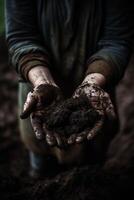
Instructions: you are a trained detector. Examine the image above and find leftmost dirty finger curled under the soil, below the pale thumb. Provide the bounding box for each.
[30,114,45,140]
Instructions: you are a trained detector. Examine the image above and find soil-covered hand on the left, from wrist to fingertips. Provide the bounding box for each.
[20,84,64,147]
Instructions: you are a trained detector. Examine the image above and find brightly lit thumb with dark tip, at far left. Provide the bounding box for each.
[20,92,37,119]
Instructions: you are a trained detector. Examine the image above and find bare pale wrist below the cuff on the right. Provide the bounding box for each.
[83,73,106,87]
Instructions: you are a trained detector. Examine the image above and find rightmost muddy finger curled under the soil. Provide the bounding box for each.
[87,118,104,140]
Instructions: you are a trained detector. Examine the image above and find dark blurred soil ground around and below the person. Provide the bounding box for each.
[0,38,134,200]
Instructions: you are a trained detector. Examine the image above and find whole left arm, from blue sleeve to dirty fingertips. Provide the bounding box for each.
[6,0,65,146]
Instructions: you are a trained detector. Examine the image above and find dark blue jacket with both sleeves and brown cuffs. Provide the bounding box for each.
[6,0,131,87]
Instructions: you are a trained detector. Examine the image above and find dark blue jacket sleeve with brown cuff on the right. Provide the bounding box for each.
[87,0,133,83]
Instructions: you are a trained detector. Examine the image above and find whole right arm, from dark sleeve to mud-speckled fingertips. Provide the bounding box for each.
[68,0,133,144]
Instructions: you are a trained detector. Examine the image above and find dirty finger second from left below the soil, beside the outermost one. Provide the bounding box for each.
[43,124,57,147]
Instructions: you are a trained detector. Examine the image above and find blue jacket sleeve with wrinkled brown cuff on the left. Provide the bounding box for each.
[5,0,49,79]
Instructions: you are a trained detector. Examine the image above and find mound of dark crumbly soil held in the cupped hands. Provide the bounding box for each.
[44,96,100,138]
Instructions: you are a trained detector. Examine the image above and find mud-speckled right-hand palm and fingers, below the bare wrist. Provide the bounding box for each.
[68,73,116,144]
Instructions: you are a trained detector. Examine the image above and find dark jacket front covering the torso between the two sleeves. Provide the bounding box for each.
[35,0,102,94]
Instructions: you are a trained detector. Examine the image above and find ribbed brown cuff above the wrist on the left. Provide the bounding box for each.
[18,53,50,81]
